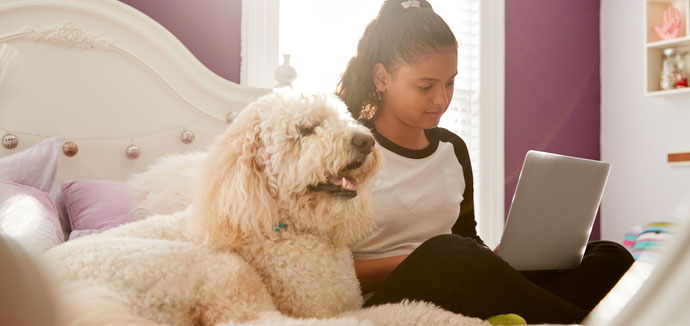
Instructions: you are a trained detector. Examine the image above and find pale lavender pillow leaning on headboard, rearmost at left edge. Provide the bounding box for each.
[0,137,62,196]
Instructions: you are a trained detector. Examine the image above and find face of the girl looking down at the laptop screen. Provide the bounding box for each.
[374,46,458,129]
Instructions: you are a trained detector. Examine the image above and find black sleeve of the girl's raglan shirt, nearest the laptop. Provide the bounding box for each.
[438,128,484,245]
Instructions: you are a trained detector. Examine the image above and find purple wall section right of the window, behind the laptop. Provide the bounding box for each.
[505,0,600,239]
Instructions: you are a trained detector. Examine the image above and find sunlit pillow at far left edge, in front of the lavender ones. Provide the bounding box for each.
[0,181,64,255]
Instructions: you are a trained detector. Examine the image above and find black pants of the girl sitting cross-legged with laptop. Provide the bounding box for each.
[364,234,633,324]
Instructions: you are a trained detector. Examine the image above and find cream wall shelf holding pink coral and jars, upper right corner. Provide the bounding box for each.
[644,0,690,96]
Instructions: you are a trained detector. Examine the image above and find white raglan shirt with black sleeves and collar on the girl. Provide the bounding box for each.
[350,124,483,260]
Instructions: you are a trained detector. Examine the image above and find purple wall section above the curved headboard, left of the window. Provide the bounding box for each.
[120,0,242,83]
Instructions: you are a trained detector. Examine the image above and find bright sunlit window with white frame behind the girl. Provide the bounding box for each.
[242,0,504,246]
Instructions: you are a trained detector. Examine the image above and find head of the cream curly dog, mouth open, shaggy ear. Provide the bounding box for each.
[194,93,379,246]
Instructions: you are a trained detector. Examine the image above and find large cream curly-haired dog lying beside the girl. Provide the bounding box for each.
[43,93,484,325]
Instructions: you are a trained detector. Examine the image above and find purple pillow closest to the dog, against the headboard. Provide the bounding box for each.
[62,180,134,240]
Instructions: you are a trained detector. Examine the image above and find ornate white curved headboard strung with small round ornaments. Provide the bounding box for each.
[0,0,269,180]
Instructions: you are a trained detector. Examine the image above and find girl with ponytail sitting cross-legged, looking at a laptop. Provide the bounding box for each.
[336,0,633,323]
